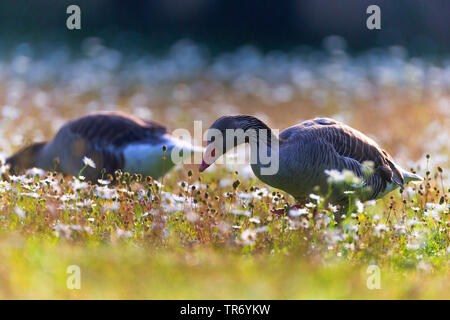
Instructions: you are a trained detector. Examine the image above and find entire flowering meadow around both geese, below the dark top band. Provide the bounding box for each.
[0,41,450,299]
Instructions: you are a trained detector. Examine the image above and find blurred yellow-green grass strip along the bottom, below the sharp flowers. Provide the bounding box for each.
[0,239,449,299]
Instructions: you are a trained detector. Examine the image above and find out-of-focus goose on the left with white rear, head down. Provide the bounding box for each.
[6,112,202,180]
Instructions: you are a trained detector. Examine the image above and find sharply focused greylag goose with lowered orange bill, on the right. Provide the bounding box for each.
[199,115,422,205]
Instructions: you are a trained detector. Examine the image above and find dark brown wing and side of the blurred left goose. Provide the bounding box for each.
[47,112,167,178]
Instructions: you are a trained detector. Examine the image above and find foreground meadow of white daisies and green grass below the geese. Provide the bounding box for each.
[0,164,450,299]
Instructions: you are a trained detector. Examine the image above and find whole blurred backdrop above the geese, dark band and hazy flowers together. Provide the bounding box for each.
[0,0,450,174]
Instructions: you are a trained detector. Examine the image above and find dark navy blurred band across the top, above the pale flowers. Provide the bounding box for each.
[0,0,450,54]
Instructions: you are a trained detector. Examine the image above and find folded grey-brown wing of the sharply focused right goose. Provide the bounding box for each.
[280,118,404,198]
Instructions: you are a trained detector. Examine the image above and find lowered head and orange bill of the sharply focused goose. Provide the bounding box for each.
[199,115,270,172]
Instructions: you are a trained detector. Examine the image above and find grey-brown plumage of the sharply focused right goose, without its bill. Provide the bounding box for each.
[202,116,421,203]
